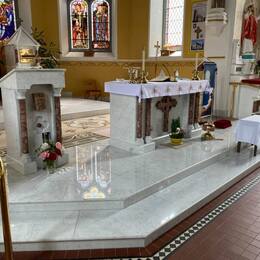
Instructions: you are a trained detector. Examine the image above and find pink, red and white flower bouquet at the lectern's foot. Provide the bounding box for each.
[36,142,63,174]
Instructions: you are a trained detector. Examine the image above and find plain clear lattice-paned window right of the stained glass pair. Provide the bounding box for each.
[163,0,184,46]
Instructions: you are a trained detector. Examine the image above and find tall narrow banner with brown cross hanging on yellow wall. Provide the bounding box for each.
[190,1,207,51]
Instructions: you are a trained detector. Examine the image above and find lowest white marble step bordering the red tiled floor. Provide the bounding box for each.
[1,145,260,250]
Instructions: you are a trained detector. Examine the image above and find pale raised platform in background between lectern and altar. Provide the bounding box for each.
[0,97,110,130]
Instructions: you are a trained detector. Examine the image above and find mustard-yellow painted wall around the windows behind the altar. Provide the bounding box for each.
[31,0,203,96]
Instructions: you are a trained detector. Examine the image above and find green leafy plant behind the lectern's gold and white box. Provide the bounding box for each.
[32,28,60,69]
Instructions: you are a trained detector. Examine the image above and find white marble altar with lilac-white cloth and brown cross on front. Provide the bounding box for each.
[105,80,209,152]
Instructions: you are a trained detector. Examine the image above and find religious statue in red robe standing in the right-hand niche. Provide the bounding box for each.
[242,4,257,53]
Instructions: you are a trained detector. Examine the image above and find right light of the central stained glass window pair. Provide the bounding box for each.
[91,0,110,49]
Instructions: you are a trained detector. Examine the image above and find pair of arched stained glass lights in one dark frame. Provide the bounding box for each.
[68,0,112,52]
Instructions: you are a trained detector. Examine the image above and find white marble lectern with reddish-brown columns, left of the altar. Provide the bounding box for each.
[0,68,68,174]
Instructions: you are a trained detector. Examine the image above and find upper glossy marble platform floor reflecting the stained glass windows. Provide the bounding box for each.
[8,125,234,210]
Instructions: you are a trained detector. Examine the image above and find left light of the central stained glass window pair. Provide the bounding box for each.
[70,0,89,49]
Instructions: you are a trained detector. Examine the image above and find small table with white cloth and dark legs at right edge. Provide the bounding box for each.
[236,115,260,156]
